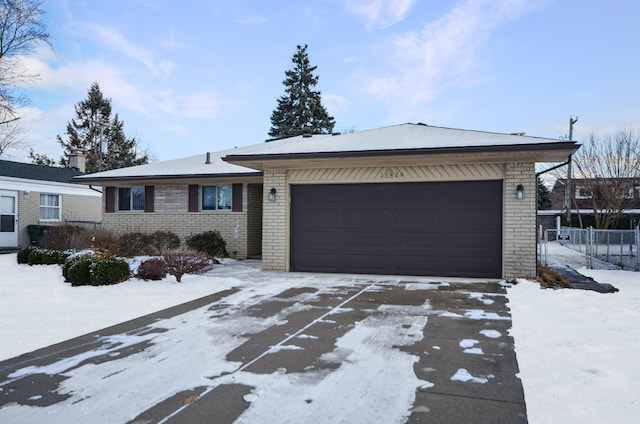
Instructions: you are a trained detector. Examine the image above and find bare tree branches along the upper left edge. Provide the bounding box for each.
[0,0,50,155]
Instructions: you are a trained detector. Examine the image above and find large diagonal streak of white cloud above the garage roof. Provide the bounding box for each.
[367,0,545,120]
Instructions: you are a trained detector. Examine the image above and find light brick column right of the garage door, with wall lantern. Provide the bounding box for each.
[503,162,537,278]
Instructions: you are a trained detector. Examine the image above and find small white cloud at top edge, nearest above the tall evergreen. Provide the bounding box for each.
[346,0,416,29]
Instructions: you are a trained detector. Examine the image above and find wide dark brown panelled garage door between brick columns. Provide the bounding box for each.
[291,181,502,278]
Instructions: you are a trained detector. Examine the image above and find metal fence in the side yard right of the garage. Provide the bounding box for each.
[538,227,640,271]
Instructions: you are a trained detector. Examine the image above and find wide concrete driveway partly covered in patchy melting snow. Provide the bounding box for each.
[0,261,527,424]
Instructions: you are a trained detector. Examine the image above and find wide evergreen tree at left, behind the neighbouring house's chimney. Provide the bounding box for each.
[57,82,149,173]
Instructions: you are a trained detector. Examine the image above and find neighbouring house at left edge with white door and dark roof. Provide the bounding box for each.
[0,160,102,249]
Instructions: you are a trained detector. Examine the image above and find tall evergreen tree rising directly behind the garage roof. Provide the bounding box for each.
[269,44,335,140]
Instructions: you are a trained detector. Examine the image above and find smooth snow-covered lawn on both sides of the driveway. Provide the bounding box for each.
[0,248,640,424]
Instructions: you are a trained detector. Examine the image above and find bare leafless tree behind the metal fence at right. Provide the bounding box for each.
[572,128,640,228]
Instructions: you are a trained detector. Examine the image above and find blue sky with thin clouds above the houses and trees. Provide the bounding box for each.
[10,0,640,161]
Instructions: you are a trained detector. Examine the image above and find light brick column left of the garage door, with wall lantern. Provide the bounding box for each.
[262,169,289,271]
